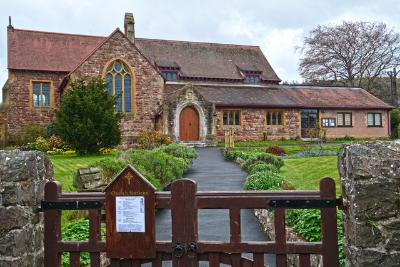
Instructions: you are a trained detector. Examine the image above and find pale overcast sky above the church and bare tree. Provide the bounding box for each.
[0,0,400,102]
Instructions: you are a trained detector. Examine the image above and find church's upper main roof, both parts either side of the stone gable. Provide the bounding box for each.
[8,29,280,83]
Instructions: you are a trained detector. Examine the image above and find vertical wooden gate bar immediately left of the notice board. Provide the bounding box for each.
[89,209,101,267]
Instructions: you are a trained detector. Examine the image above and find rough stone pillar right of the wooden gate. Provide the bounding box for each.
[339,141,400,267]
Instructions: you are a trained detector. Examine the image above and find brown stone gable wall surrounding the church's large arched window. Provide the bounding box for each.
[71,31,164,150]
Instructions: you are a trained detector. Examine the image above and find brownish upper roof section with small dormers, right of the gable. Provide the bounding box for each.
[135,38,280,82]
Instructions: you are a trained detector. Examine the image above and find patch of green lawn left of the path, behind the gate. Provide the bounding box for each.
[48,153,115,192]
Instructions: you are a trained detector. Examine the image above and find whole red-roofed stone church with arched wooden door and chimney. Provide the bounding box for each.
[0,13,392,146]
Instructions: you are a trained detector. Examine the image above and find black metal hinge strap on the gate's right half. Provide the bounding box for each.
[268,199,342,209]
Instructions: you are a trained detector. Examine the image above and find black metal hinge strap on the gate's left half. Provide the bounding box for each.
[39,200,103,211]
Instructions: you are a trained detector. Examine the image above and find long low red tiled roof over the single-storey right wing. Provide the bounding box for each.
[166,83,393,109]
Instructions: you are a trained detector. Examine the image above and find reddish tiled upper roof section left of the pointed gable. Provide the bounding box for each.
[8,29,105,72]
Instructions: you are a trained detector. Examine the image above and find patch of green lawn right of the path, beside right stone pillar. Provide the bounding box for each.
[280,156,340,195]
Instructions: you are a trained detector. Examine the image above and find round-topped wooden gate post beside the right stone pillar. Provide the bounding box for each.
[319,177,339,267]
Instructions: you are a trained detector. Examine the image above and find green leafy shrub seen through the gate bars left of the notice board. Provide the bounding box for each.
[62,219,106,267]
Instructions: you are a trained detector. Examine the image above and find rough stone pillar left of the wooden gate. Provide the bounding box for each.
[0,150,53,267]
